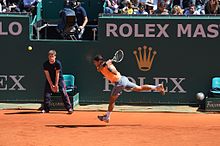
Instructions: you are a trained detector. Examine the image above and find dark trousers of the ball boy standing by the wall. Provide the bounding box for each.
[44,81,72,112]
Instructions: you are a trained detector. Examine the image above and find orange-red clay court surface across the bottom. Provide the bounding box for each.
[0,110,220,146]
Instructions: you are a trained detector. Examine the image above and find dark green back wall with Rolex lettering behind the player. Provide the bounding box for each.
[0,16,220,104]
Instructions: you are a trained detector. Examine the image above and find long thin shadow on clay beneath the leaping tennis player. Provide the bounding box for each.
[46,124,141,128]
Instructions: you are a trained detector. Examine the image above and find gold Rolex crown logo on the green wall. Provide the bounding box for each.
[133,46,157,71]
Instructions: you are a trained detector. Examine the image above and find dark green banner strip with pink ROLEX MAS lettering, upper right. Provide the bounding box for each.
[99,15,220,40]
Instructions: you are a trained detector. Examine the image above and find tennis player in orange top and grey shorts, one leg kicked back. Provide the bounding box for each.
[93,55,165,123]
